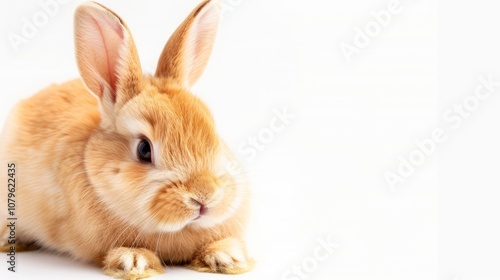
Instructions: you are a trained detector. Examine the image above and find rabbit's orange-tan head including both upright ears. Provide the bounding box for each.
[75,0,245,232]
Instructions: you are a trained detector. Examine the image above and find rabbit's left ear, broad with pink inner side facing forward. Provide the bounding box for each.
[75,2,143,109]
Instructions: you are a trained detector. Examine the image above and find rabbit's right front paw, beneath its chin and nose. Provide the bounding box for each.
[189,238,254,274]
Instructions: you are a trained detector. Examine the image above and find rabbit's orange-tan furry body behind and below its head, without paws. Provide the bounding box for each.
[0,80,250,264]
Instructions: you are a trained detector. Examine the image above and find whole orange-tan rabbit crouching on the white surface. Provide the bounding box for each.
[0,0,255,279]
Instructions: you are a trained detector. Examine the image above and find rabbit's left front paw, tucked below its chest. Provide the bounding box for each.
[104,247,164,280]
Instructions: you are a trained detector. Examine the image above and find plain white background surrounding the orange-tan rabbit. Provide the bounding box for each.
[0,0,500,280]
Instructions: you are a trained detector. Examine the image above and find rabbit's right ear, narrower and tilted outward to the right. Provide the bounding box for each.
[155,0,220,87]
